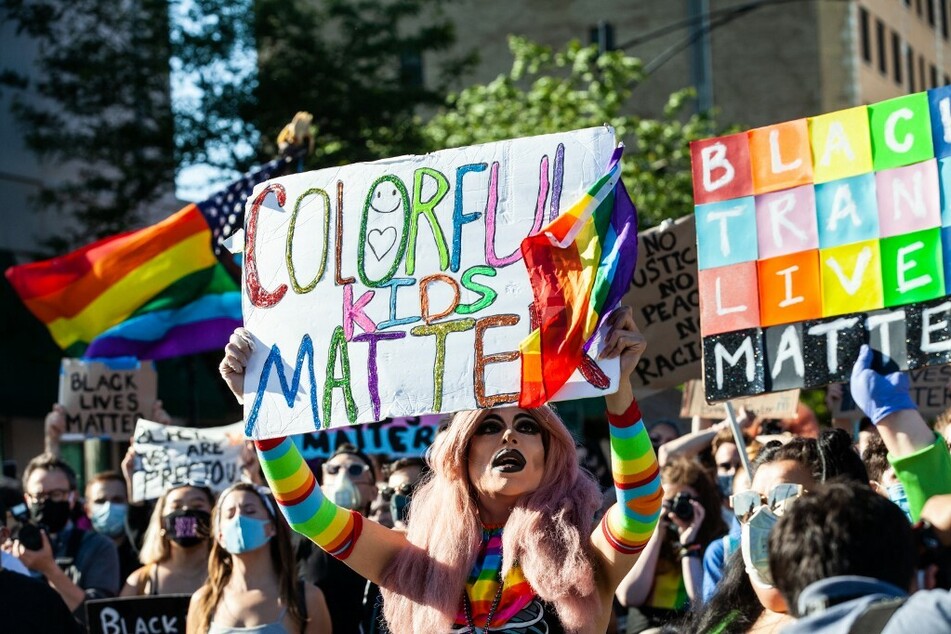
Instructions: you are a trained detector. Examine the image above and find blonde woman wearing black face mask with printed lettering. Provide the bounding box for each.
[121,483,215,597]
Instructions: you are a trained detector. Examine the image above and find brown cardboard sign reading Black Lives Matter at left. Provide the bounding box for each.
[59,357,158,440]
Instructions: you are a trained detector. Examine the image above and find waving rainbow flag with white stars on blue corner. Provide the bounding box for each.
[6,156,295,359]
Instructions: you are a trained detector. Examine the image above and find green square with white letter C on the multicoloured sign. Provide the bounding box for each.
[868,92,934,171]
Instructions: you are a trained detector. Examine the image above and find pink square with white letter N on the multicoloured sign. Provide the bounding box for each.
[875,159,941,238]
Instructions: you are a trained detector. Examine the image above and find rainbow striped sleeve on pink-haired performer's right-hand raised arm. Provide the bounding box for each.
[601,400,664,555]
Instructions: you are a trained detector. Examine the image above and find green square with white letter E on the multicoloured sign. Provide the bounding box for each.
[881,227,944,307]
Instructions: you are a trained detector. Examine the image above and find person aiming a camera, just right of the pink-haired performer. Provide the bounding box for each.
[616,458,727,631]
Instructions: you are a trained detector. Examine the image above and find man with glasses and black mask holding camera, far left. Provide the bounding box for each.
[13,454,120,622]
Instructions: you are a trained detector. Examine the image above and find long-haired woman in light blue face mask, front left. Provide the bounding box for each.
[186,482,331,634]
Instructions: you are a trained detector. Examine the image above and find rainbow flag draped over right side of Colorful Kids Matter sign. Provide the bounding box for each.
[518,146,637,408]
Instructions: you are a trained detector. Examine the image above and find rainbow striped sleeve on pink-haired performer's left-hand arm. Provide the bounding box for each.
[254,437,363,560]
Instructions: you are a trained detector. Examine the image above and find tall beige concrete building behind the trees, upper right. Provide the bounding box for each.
[442,0,951,127]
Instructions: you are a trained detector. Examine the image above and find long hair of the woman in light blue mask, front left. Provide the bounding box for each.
[188,482,307,632]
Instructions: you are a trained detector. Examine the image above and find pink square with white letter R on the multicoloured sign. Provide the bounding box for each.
[756,185,819,260]
